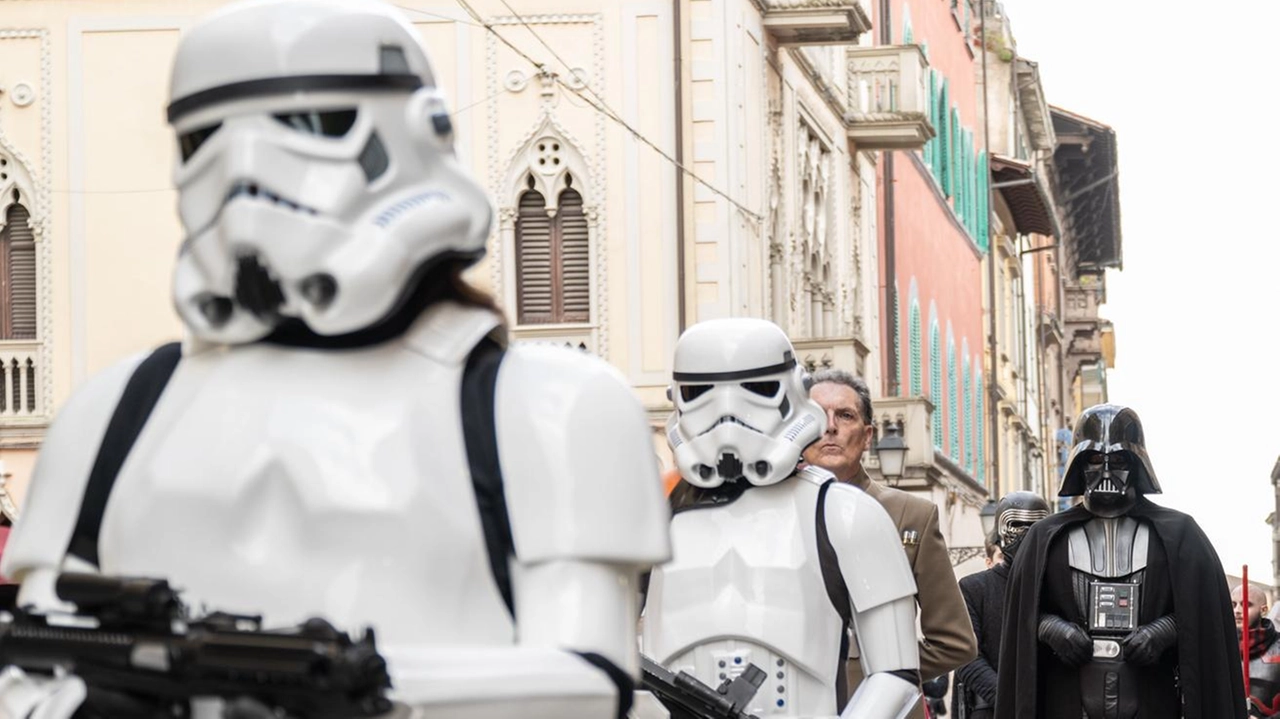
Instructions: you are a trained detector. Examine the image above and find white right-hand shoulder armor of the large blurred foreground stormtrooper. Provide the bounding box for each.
[495,344,671,564]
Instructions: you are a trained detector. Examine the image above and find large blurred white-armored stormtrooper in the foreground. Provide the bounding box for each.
[0,0,669,719]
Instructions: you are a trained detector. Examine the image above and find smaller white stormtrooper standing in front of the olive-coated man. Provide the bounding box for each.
[643,319,920,719]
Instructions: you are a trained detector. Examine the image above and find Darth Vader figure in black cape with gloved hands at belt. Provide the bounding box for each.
[996,404,1245,719]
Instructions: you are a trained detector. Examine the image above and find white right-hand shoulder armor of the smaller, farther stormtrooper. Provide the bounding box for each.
[824,482,915,612]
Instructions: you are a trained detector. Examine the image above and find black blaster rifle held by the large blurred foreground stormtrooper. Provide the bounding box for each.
[0,573,392,719]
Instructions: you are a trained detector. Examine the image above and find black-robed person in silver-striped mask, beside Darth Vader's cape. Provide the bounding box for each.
[951,491,1050,719]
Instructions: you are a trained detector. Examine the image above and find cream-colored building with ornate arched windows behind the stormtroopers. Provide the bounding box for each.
[0,0,928,498]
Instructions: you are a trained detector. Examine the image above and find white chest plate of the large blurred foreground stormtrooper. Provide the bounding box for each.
[100,342,513,646]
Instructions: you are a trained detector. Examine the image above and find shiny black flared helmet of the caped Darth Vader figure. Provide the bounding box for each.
[1057,404,1161,517]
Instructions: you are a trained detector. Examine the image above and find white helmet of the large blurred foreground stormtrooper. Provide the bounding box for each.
[168,0,492,344]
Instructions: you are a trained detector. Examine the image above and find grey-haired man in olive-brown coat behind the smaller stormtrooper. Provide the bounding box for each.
[804,370,978,719]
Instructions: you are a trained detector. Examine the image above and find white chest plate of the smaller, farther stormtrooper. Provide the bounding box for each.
[644,478,844,715]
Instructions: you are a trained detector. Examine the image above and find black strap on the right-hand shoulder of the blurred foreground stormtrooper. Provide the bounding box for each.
[462,338,516,615]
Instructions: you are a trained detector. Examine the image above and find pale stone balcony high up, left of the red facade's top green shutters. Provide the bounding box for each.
[845,45,936,150]
